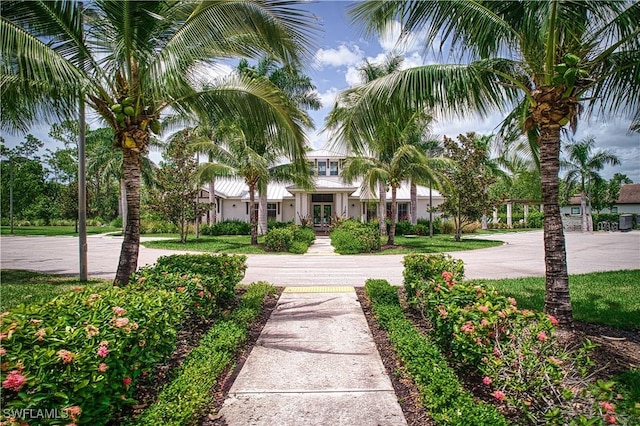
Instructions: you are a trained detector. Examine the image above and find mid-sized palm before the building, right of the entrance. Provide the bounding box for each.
[342,144,440,245]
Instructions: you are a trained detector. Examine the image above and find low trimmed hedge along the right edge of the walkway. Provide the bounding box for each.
[365,279,508,426]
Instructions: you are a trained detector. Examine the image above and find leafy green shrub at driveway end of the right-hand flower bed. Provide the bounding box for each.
[402,254,464,299]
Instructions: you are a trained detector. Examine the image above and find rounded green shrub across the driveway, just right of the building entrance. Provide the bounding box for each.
[330,220,380,254]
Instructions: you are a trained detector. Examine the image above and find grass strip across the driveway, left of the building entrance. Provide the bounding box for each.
[140,235,266,254]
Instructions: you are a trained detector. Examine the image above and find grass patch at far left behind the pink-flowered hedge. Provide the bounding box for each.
[0,269,111,312]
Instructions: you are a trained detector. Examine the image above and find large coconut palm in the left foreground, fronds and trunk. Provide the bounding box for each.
[0,0,315,284]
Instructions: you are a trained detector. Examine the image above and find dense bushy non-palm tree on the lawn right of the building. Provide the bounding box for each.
[440,133,501,241]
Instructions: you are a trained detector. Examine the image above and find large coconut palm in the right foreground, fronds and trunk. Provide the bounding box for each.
[350,0,640,325]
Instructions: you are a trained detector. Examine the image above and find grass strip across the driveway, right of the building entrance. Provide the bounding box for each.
[377,234,502,254]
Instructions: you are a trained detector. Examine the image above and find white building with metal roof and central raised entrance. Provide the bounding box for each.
[200,150,443,230]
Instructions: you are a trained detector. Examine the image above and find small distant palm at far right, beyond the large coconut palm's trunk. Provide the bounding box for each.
[560,137,620,232]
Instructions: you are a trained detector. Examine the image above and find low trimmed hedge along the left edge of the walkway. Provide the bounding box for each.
[135,283,276,426]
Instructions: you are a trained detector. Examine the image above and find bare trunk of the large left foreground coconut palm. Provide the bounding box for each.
[114,149,140,285]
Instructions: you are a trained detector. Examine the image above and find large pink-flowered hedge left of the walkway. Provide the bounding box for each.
[0,255,246,425]
